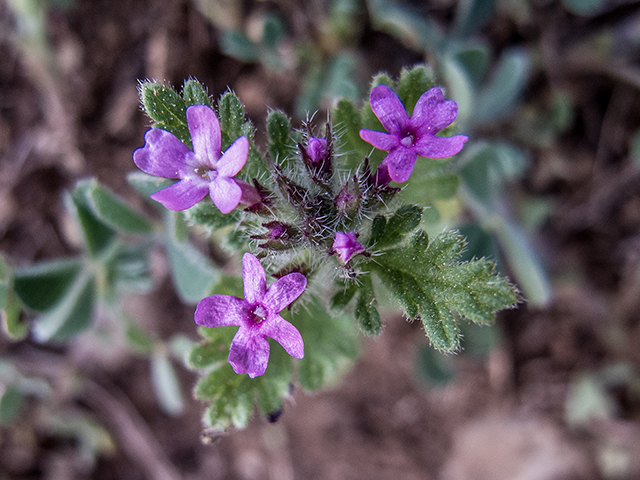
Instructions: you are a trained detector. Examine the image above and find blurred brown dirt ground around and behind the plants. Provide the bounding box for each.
[0,0,640,480]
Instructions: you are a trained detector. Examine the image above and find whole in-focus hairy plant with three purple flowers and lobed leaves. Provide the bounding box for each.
[126,66,518,431]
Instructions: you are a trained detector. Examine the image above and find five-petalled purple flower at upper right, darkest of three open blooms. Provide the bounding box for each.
[360,85,469,183]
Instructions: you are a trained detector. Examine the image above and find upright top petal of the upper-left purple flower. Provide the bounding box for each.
[187,105,220,168]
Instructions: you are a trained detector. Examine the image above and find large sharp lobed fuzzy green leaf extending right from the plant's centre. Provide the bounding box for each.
[370,231,519,352]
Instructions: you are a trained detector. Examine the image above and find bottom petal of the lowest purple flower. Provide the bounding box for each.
[229,327,269,378]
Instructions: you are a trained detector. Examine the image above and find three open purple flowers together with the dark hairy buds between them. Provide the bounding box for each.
[133,80,468,378]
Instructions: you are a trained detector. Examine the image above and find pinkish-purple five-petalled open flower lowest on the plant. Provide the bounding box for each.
[194,253,307,378]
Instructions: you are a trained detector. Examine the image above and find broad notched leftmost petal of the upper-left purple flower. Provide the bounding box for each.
[133,128,193,178]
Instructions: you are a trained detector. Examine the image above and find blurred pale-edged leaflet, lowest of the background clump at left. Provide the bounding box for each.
[33,270,96,343]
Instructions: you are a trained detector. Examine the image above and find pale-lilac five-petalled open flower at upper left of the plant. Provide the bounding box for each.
[133,105,249,213]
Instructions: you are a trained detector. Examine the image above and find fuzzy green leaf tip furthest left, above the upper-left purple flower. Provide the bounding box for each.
[140,82,191,148]
